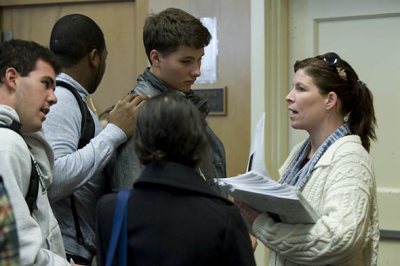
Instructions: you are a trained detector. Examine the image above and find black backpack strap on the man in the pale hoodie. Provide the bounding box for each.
[0,121,39,215]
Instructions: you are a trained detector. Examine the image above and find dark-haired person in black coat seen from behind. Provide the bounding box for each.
[96,93,255,266]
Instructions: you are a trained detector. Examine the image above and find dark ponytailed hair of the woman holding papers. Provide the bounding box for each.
[294,52,376,151]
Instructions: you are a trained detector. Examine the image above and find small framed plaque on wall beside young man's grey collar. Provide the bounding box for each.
[193,87,227,115]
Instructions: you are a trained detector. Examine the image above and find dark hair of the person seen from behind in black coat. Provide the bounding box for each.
[134,93,208,168]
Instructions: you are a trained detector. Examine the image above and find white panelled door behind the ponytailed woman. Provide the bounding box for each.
[289,0,400,265]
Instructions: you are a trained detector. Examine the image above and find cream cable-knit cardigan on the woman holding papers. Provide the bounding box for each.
[253,135,379,266]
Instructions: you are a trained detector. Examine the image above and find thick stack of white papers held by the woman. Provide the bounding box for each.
[216,114,318,223]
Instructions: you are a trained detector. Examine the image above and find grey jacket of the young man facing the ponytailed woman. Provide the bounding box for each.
[109,69,226,192]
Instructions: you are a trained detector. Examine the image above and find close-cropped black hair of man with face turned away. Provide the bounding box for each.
[50,14,106,67]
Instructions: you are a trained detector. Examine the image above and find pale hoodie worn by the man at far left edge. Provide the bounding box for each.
[0,105,70,266]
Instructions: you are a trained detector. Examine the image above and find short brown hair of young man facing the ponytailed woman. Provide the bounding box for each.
[143,8,211,62]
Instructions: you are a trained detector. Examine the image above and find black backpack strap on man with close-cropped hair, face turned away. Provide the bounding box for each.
[56,80,94,245]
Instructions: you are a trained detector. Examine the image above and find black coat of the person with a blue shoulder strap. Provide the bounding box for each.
[97,162,255,266]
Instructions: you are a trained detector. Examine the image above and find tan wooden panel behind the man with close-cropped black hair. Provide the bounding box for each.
[0,0,147,112]
